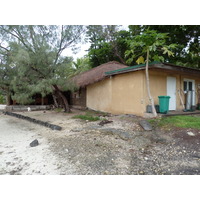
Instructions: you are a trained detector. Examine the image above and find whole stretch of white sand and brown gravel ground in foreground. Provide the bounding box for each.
[0,110,200,175]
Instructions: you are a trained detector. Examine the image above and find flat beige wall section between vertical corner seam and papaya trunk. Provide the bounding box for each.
[111,71,144,115]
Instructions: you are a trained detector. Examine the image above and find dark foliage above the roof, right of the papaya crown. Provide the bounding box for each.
[142,25,200,68]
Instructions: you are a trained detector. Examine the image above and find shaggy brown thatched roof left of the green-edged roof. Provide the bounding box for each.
[73,61,128,87]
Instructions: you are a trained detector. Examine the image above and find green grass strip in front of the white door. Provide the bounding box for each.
[149,116,200,129]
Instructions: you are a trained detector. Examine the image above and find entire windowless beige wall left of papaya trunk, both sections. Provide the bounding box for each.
[87,71,144,115]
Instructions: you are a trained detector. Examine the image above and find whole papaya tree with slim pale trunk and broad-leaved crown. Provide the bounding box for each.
[126,30,176,117]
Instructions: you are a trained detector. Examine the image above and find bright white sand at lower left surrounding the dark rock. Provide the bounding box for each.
[0,114,64,175]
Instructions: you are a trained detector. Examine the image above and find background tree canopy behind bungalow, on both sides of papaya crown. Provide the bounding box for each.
[88,25,200,68]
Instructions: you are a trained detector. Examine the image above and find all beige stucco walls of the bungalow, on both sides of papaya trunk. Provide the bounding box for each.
[86,70,200,116]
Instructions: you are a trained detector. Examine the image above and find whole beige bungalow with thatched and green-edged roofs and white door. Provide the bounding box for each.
[74,61,200,116]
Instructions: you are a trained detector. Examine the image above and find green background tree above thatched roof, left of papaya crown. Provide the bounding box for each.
[86,25,129,67]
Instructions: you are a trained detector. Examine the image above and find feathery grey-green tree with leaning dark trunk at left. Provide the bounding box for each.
[0,25,84,111]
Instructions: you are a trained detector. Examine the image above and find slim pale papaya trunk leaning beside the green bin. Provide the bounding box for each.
[145,50,158,117]
